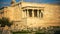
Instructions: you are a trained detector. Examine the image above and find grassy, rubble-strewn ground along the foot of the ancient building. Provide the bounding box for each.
[0,26,60,34]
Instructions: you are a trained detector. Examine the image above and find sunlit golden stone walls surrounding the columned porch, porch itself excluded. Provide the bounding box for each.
[4,2,60,29]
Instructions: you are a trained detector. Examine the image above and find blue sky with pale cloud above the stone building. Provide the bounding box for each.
[0,0,60,8]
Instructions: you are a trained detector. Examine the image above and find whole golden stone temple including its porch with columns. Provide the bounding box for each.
[0,1,60,29]
